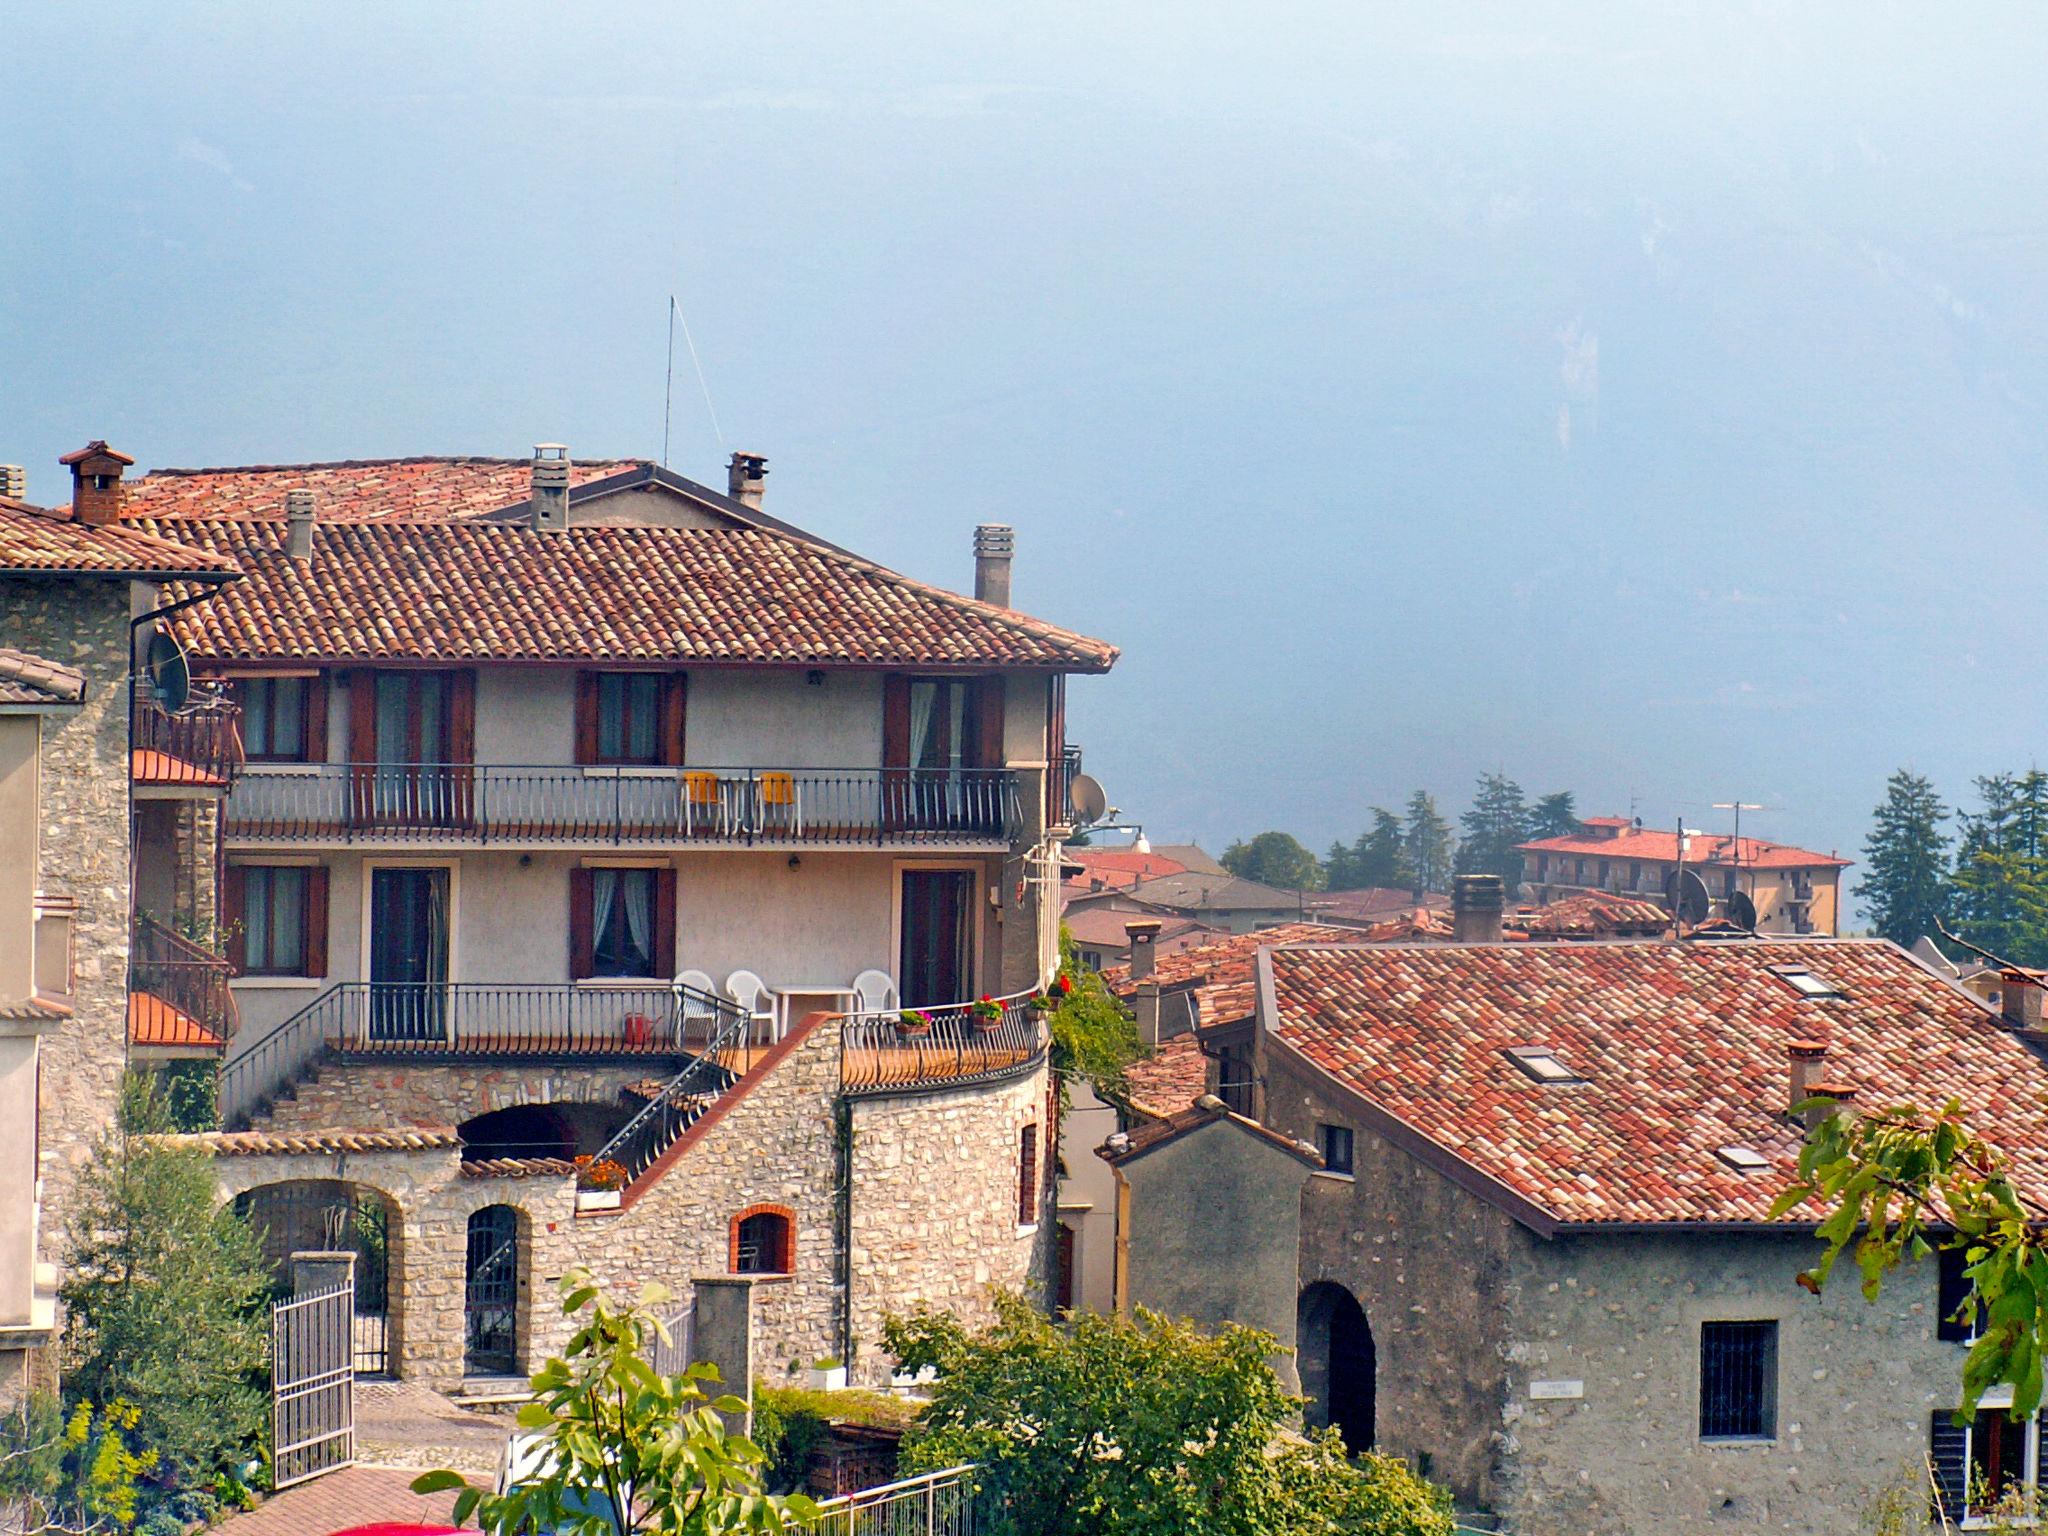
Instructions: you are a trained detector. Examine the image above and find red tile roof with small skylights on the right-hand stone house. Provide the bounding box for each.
[1264,940,2048,1231]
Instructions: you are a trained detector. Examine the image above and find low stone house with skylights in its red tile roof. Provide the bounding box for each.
[1104,925,2048,1534]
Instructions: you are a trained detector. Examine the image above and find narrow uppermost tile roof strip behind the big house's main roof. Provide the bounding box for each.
[125,457,645,522]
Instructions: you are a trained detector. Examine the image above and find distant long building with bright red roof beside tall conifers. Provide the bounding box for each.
[1522,815,1849,936]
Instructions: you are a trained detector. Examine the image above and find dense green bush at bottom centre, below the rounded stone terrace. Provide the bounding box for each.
[883,1294,1454,1536]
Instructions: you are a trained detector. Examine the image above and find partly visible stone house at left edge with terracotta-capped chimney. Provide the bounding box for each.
[0,475,233,1401]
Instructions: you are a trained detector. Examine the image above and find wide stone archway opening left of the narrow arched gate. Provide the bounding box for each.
[236,1180,403,1376]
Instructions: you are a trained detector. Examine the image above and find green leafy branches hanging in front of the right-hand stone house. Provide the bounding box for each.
[1772,1100,2048,1421]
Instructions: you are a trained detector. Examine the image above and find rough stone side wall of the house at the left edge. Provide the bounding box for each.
[0,582,129,1257]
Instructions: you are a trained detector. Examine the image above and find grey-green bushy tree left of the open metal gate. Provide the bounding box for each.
[61,1075,270,1487]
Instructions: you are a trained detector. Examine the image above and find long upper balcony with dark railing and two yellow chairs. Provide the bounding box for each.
[223,764,1020,848]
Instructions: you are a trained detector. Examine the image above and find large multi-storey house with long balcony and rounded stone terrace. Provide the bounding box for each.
[123,444,1116,1386]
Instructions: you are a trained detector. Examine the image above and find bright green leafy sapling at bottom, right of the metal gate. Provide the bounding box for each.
[412,1270,817,1536]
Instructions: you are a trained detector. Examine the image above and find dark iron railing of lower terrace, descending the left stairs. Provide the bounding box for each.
[219,981,745,1126]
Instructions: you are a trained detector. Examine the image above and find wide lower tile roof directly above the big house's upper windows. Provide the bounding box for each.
[143,520,1116,672]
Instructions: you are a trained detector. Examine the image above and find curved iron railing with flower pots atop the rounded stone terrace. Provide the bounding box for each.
[840,991,1051,1096]
